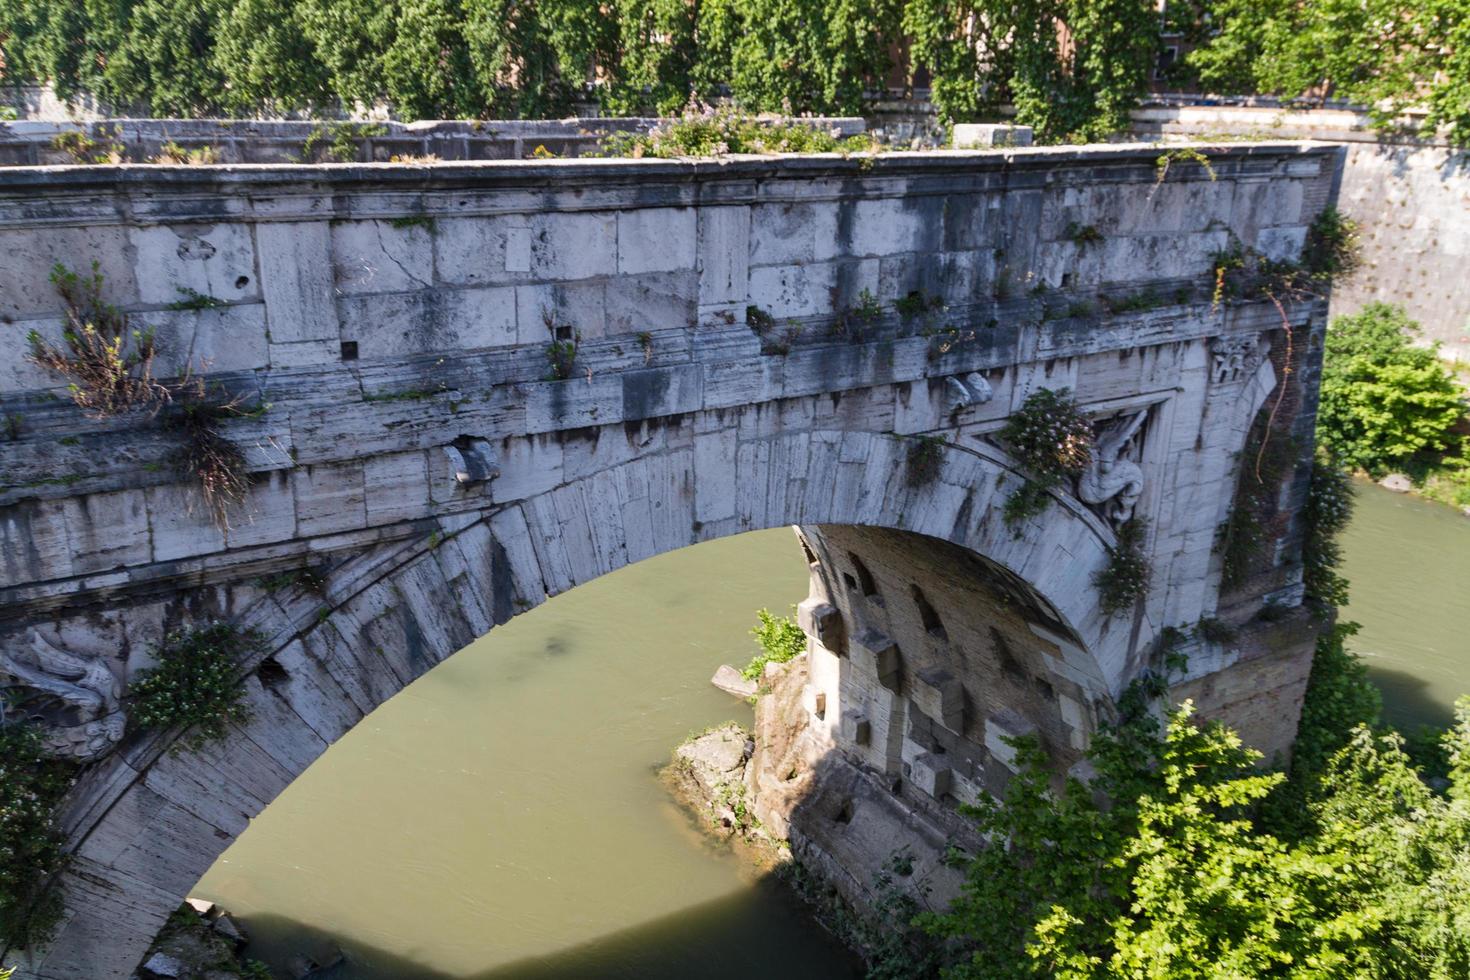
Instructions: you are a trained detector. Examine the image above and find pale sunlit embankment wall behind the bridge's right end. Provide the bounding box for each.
[1133,106,1470,360]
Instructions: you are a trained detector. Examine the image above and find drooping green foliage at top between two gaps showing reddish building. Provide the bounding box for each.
[903,0,1158,143]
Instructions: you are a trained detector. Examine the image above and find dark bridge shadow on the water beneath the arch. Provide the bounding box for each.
[245,874,863,980]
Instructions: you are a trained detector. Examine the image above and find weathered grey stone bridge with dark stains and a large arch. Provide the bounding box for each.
[0,144,1341,980]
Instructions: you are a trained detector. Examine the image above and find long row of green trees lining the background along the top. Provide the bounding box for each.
[0,0,1470,145]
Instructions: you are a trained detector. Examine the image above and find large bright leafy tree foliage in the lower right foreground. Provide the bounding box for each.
[919,690,1470,980]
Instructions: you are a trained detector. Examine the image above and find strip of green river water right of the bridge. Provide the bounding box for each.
[1342,482,1470,730]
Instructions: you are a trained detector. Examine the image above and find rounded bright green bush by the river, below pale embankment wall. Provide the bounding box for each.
[1317,303,1466,475]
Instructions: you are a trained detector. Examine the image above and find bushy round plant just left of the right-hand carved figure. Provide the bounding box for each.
[1000,388,1092,526]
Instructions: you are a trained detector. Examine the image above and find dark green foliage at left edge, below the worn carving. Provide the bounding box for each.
[0,724,74,948]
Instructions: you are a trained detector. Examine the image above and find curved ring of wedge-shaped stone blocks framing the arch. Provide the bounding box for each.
[8,430,1130,980]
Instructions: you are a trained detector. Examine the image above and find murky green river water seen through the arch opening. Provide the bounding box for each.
[196,529,853,980]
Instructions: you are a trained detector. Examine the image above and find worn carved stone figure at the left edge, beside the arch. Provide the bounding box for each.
[0,629,126,760]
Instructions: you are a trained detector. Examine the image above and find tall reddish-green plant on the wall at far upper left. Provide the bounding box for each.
[28,262,169,419]
